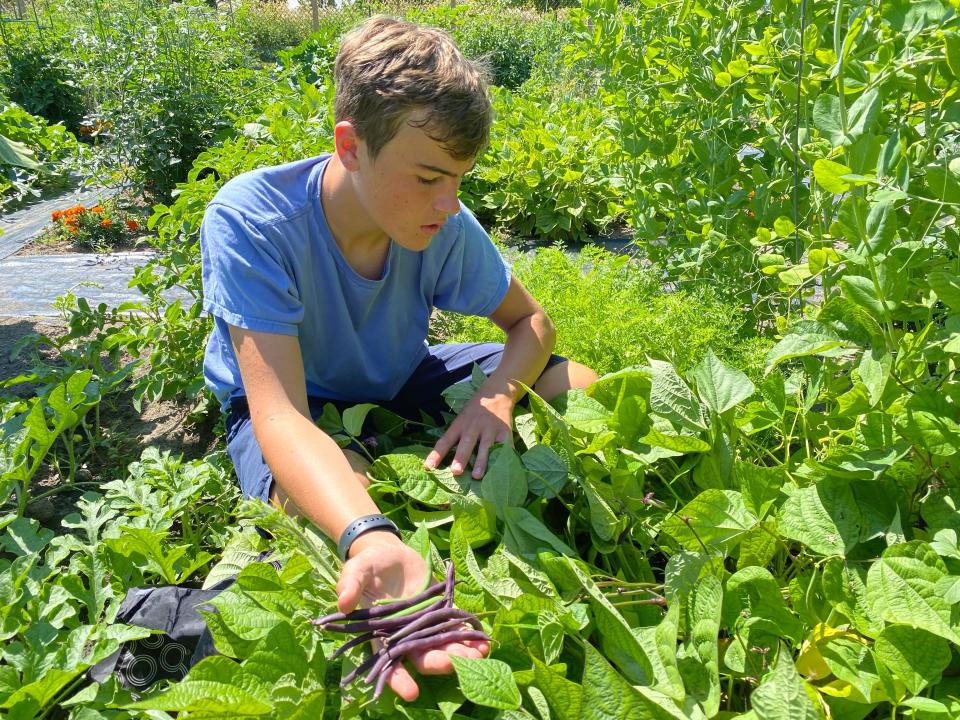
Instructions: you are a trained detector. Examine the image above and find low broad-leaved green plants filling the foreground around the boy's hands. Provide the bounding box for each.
[0,344,960,718]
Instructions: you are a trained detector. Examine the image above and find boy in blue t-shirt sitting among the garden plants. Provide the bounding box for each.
[201,17,596,700]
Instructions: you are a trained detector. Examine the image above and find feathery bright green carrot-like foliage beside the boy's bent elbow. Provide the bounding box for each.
[432,246,761,374]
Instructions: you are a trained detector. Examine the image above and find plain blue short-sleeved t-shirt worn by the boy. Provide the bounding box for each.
[200,155,510,409]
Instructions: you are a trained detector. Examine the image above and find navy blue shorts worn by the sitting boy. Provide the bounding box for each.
[226,343,566,502]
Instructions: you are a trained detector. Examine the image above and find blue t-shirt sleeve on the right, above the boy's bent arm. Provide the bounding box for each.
[433,205,510,317]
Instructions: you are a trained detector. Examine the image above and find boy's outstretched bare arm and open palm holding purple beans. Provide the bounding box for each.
[229,325,490,700]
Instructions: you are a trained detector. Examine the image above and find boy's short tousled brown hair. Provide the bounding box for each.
[333,15,493,160]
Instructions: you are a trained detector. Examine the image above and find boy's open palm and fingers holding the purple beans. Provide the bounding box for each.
[337,532,490,702]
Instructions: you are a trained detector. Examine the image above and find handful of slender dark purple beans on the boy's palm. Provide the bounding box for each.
[313,563,490,700]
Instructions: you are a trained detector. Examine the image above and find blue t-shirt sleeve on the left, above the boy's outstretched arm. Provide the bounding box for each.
[200,203,303,335]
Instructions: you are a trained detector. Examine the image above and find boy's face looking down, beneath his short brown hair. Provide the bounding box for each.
[355,113,473,251]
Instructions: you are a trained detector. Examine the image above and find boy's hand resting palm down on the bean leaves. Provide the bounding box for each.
[424,388,514,480]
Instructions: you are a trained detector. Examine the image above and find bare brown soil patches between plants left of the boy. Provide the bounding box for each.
[0,317,219,533]
